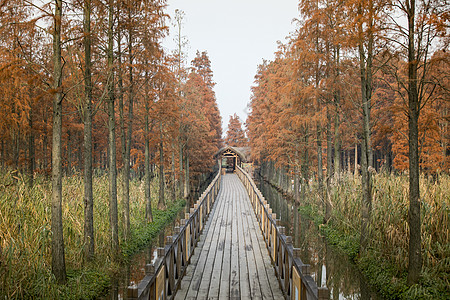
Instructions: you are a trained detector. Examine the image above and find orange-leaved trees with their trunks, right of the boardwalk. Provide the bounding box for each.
[247,0,450,285]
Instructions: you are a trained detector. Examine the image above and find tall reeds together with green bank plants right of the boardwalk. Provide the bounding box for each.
[262,173,450,299]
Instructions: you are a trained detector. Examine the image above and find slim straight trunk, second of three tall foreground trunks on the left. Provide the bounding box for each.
[83,0,95,261]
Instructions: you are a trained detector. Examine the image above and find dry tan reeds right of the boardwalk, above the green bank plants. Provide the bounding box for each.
[305,173,450,297]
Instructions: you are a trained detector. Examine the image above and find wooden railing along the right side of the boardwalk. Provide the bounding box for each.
[236,167,330,300]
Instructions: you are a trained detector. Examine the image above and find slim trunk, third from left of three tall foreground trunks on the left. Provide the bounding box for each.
[107,0,119,260]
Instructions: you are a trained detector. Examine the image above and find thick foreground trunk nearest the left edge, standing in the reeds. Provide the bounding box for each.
[51,0,67,284]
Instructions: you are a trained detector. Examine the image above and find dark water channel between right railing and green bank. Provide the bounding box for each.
[258,180,382,300]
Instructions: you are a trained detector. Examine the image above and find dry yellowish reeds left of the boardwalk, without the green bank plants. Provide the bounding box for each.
[0,172,162,299]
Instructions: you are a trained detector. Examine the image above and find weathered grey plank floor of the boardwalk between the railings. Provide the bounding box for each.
[175,174,284,299]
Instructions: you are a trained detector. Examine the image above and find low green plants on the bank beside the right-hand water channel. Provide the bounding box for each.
[264,179,450,300]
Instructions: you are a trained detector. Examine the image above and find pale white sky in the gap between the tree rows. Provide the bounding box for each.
[164,0,298,134]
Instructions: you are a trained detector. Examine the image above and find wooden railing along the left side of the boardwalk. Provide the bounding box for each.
[127,169,222,300]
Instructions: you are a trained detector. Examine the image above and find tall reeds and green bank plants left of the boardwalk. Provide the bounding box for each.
[0,172,186,299]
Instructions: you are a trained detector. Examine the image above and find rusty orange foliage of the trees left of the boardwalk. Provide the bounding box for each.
[0,0,222,188]
